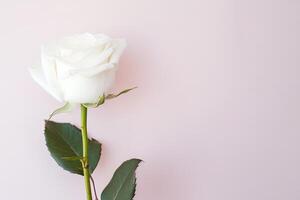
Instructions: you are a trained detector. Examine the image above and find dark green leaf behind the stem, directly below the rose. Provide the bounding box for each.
[45,121,101,175]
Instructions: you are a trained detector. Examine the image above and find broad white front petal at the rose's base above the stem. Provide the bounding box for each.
[61,69,115,103]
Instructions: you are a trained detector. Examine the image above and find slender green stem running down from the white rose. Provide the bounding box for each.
[80,105,92,200]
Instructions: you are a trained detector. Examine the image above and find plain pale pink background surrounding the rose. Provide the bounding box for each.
[0,0,300,200]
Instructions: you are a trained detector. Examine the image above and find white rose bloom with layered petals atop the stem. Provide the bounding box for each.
[30,33,126,104]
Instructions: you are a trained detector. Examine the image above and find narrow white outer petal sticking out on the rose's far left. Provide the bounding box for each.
[29,66,63,101]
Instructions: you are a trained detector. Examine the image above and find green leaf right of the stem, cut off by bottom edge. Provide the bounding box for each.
[101,159,141,200]
